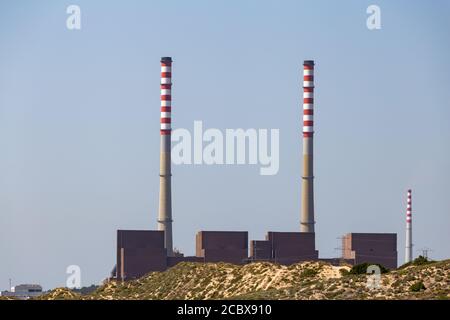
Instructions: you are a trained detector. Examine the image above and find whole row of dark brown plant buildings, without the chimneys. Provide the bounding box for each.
[112,230,397,280]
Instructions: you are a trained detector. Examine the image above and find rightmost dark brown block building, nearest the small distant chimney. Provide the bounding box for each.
[342,233,397,269]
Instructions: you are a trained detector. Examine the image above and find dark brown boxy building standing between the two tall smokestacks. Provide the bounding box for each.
[195,231,248,264]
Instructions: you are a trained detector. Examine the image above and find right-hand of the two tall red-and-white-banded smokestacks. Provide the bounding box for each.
[300,60,315,232]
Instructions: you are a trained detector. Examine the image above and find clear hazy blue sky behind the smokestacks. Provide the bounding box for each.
[0,0,450,289]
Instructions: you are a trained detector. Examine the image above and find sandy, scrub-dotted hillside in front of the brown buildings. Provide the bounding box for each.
[40,260,450,299]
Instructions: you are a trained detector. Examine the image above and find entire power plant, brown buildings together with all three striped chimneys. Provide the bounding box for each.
[111,57,404,280]
